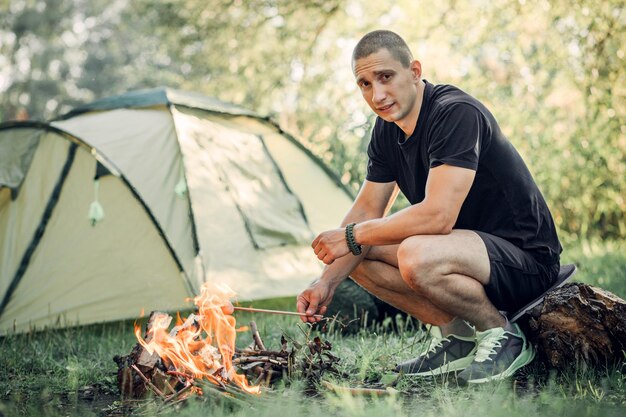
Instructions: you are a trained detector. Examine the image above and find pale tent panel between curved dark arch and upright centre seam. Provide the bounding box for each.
[52,108,197,279]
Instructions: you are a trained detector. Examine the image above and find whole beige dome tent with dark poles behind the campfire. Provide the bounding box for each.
[0,88,352,334]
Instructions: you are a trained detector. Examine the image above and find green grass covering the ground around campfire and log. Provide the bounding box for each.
[0,237,626,417]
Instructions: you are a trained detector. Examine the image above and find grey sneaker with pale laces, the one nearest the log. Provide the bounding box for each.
[457,324,535,384]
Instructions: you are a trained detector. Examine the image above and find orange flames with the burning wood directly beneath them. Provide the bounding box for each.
[114,286,259,401]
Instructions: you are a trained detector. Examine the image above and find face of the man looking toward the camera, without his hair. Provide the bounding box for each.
[353,48,421,122]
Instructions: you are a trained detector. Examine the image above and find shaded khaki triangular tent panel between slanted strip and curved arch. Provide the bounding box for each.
[0,148,192,328]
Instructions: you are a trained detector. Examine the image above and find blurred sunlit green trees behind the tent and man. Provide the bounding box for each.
[0,0,626,241]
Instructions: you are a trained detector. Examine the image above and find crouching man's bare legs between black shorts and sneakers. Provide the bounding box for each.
[352,230,506,330]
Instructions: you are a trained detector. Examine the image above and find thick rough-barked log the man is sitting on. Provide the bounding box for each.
[523,283,626,369]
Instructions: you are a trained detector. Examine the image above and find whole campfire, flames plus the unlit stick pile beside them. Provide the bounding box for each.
[114,284,339,402]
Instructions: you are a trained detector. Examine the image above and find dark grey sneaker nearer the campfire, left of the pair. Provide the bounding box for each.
[395,335,476,376]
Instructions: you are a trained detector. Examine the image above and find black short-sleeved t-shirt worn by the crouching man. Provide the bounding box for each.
[367,81,562,265]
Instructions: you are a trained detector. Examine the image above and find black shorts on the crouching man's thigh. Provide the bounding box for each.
[476,231,559,312]
